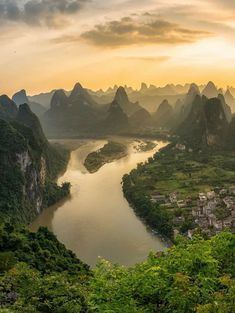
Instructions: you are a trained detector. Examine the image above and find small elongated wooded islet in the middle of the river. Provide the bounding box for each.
[84,141,127,173]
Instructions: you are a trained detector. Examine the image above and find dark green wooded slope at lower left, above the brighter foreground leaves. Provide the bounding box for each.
[0,223,87,275]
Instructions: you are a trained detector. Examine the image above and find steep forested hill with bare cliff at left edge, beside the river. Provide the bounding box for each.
[0,96,69,223]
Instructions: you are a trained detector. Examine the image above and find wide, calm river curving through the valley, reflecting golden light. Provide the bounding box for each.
[30,140,166,266]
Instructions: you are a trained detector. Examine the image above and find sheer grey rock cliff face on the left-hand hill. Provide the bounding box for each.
[0,120,47,222]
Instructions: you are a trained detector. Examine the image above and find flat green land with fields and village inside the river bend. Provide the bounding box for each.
[123,145,235,237]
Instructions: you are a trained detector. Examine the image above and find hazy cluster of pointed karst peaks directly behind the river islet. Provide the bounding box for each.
[41,83,149,136]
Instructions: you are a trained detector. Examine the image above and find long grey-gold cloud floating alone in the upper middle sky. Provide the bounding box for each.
[79,13,211,47]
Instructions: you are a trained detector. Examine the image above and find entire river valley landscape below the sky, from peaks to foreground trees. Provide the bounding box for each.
[0,82,235,313]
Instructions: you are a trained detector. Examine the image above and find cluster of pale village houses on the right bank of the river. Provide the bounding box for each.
[151,186,235,238]
